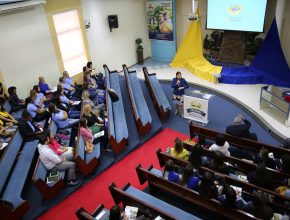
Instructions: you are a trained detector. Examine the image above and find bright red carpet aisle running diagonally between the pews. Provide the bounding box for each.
[38,128,187,220]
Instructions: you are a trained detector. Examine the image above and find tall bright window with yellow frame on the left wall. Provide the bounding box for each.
[52,10,87,76]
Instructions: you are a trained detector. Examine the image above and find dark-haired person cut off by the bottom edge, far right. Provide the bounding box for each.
[253,192,274,220]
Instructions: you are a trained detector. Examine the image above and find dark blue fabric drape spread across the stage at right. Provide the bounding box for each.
[220,19,290,88]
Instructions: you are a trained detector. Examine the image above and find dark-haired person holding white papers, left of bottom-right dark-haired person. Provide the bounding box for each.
[218,185,253,212]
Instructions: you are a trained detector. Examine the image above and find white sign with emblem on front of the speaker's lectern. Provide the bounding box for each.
[183,95,208,124]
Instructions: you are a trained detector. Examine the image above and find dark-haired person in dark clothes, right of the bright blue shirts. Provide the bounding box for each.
[198,171,218,199]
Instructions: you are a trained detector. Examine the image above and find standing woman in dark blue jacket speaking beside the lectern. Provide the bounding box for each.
[171,72,189,116]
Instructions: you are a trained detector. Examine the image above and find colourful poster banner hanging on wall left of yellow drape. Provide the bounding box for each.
[146,1,173,41]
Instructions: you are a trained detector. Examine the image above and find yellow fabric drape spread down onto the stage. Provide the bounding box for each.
[170,20,222,82]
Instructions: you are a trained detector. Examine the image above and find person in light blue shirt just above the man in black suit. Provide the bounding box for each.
[26,96,49,122]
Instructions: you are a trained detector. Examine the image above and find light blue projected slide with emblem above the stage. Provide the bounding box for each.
[207,0,267,32]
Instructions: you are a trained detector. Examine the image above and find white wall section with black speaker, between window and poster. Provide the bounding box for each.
[82,0,150,71]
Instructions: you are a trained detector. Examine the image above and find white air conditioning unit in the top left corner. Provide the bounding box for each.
[0,0,46,13]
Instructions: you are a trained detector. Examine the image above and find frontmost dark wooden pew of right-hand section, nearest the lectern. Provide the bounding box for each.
[189,123,290,157]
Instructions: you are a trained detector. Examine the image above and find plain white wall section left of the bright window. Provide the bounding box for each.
[0,6,59,98]
